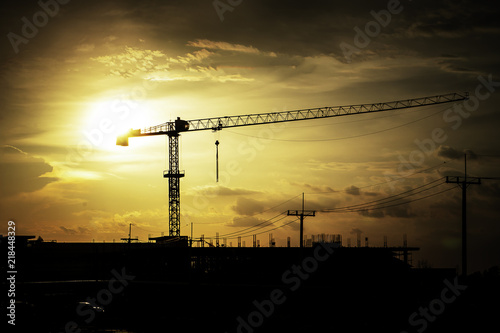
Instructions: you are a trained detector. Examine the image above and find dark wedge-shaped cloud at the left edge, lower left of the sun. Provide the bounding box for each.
[0,146,58,196]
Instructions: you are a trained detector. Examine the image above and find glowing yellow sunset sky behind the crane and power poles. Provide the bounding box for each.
[0,0,500,271]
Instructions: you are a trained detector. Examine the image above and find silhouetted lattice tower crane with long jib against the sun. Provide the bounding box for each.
[116,92,469,236]
